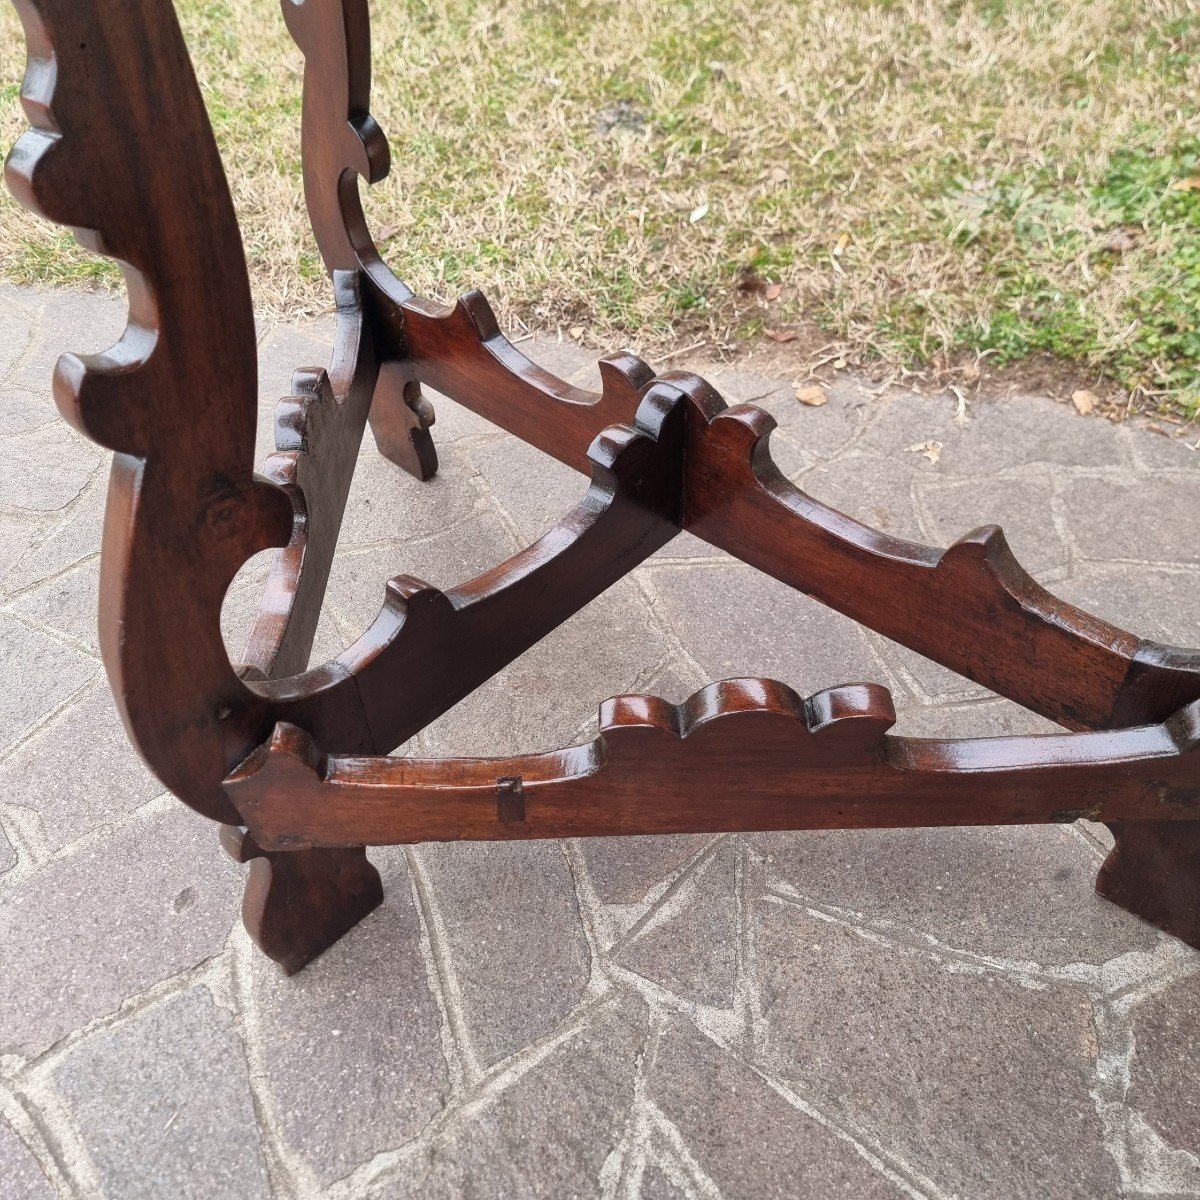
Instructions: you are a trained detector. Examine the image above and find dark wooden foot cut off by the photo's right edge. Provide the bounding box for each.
[1096,821,1200,949]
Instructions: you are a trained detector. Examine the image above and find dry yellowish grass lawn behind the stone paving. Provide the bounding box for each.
[0,0,1200,414]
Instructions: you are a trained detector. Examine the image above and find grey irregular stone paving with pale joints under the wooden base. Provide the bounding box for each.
[0,289,1200,1200]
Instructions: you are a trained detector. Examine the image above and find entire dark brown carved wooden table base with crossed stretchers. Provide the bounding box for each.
[7,0,1200,971]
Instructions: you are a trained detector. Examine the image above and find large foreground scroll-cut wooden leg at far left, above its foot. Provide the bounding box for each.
[6,0,292,820]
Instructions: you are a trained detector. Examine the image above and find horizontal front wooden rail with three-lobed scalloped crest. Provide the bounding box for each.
[227,679,1200,883]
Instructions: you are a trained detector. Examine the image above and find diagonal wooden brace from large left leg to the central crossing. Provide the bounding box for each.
[248,386,683,754]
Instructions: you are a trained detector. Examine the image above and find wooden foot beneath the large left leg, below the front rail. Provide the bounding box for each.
[221,826,383,974]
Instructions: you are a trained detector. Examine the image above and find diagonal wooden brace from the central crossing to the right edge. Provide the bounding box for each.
[665,374,1200,728]
